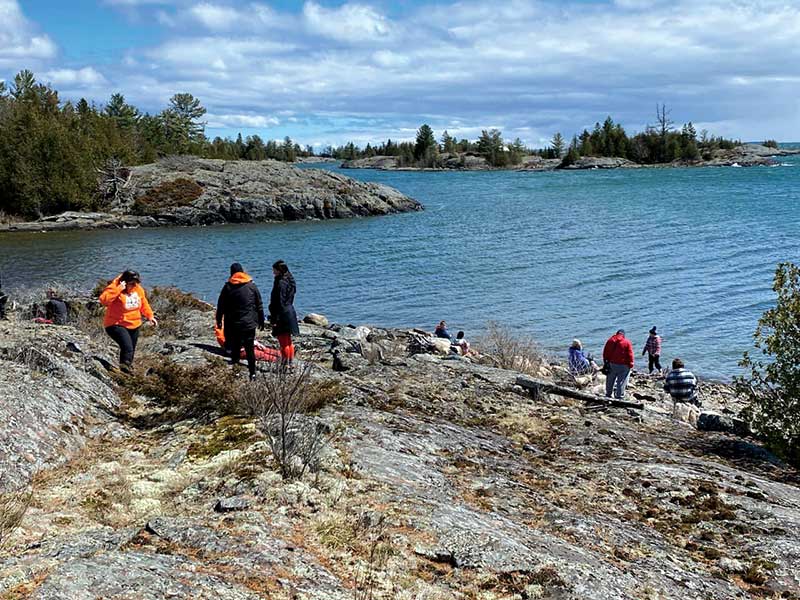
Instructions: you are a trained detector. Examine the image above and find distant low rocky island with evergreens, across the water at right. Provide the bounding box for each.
[334,112,800,171]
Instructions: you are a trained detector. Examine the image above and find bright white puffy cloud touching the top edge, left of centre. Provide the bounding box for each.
[303,0,394,44]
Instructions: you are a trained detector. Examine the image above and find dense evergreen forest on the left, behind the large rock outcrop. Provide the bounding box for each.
[0,70,311,218]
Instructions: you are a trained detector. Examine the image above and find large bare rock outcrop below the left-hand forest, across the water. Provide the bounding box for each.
[0,157,423,233]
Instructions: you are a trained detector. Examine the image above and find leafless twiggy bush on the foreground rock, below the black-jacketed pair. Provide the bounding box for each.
[243,363,329,479]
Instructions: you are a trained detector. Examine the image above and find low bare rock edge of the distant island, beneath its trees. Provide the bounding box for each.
[342,144,800,171]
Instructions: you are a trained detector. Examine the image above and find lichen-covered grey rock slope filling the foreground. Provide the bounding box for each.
[0,293,800,600]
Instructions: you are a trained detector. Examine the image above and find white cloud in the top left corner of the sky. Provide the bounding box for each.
[0,0,57,68]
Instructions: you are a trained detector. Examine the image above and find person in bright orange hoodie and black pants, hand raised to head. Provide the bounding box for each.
[100,270,158,373]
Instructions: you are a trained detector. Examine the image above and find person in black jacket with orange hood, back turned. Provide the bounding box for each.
[217,263,264,379]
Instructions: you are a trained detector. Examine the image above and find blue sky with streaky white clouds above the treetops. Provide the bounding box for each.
[0,0,800,148]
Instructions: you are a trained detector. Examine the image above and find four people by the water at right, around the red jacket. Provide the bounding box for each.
[568,327,699,404]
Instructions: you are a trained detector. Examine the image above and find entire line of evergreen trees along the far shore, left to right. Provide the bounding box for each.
[0,70,748,218]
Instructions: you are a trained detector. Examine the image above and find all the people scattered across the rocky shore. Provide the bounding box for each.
[0,260,699,404]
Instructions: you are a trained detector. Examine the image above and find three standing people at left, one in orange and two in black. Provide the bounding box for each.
[100,260,300,379]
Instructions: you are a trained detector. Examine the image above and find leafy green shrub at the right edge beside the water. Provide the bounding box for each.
[735,262,800,466]
